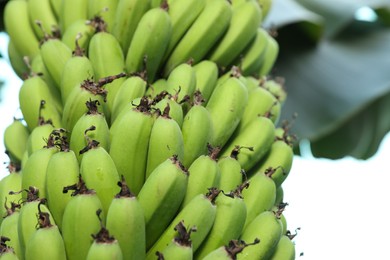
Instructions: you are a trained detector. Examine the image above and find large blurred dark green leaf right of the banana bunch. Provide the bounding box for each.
[266,0,390,159]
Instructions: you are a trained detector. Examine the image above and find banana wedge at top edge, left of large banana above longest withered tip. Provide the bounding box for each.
[112,0,150,56]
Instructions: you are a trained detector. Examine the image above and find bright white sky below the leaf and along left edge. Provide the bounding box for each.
[0,33,390,260]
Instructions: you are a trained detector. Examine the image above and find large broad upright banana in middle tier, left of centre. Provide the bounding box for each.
[110,97,154,194]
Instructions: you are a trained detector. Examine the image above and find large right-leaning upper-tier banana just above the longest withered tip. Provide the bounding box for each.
[126,6,172,82]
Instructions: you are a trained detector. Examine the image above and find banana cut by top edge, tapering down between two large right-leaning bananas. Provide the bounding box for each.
[163,0,207,63]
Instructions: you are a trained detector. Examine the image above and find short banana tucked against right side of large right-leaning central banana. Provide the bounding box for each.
[181,145,220,208]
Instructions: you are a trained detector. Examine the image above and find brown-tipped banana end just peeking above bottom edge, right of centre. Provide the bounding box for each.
[203,239,260,260]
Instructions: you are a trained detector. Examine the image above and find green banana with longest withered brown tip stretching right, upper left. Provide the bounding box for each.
[62,73,126,131]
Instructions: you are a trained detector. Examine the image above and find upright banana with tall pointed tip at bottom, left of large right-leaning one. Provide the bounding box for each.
[106,176,146,260]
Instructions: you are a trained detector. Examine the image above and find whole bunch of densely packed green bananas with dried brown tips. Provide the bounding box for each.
[0,0,295,260]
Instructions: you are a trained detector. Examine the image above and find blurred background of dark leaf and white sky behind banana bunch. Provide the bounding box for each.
[0,0,390,260]
